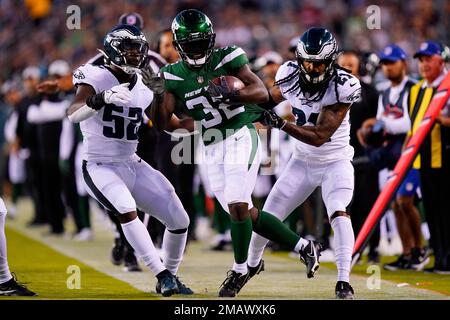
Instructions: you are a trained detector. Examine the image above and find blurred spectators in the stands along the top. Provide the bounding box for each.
[0,0,450,82]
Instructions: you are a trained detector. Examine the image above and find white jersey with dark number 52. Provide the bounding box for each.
[73,64,153,162]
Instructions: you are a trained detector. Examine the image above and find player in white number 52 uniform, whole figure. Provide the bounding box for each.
[68,25,192,296]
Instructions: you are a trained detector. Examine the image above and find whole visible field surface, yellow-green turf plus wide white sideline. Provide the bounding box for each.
[0,202,450,300]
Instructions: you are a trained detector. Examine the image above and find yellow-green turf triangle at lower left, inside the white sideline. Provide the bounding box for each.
[0,229,148,299]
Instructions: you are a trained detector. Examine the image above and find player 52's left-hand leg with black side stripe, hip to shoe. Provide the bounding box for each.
[83,161,178,296]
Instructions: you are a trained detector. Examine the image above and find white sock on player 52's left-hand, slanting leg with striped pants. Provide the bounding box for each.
[122,217,166,276]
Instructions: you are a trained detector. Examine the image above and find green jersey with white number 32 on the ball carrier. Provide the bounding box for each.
[161,46,263,145]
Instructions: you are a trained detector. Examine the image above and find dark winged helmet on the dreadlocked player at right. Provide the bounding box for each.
[295,28,338,84]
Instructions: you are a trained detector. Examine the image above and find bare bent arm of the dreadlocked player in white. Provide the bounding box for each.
[283,103,350,147]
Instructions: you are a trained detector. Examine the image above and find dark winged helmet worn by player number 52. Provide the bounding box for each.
[102,25,148,74]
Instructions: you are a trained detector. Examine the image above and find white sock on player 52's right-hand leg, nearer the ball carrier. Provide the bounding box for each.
[162,229,187,275]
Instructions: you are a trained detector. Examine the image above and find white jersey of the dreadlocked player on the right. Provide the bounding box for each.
[275,61,361,162]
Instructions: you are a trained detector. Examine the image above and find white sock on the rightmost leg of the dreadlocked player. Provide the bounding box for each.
[331,216,355,282]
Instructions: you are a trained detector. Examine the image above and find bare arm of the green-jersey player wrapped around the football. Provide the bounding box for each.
[235,64,269,103]
